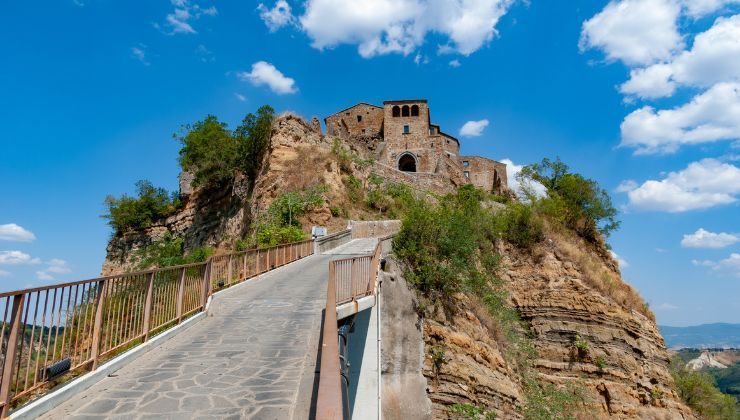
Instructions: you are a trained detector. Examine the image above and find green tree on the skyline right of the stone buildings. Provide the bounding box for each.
[518,158,619,241]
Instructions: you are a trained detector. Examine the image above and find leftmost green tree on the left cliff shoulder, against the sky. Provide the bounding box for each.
[101,180,181,234]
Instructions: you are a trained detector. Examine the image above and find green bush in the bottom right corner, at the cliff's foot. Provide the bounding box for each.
[671,357,740,420]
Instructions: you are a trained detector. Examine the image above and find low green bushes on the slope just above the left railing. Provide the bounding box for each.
[134,233,213,270]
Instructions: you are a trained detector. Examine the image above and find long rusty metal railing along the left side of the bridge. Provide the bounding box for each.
[0,240,314,417]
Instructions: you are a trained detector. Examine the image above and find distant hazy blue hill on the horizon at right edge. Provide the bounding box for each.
[659,323,740,349]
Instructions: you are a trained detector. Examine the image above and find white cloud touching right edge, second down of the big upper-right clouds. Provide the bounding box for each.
[621,15,740,98]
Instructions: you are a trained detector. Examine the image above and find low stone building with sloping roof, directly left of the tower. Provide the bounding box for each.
[324,103,383,140]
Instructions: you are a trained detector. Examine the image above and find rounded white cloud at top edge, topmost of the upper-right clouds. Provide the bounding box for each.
[579,0,683,65]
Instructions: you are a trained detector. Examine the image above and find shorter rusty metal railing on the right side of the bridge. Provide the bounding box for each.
[316,241,382,420]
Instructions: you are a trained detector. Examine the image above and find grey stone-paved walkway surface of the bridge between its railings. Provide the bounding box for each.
[42,239,376,420]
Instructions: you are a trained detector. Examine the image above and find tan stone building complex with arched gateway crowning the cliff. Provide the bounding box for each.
[324,99,507,193]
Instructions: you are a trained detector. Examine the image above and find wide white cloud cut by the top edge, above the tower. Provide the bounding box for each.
[299,0,513,58]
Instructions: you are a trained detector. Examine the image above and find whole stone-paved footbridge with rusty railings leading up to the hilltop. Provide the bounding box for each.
[0,222,397,419]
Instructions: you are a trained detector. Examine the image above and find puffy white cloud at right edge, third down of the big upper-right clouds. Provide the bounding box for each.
[620,83,740,154]
